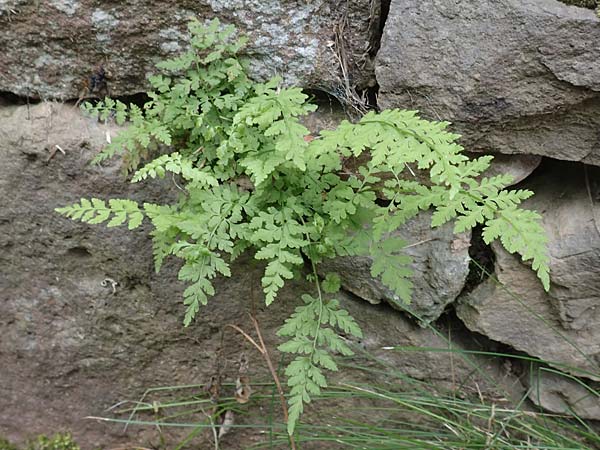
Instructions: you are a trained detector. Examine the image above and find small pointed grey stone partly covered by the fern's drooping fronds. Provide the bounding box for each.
[321,213,471,325]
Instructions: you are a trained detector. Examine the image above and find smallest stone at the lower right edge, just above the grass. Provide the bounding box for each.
[528,370,600,420]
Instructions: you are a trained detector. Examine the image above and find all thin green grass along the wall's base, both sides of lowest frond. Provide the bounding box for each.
[91,347,600,450]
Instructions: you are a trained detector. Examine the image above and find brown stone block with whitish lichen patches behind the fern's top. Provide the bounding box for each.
[0,0,379,99]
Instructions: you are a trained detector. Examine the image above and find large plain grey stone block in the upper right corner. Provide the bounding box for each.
[376,0,600,165]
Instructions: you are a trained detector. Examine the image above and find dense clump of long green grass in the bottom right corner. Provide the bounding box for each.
[257,356,600,450]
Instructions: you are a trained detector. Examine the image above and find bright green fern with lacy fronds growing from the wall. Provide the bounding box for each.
[57,20,549,434]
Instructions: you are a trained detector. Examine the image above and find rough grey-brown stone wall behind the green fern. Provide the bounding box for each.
[0,0,600,448]
